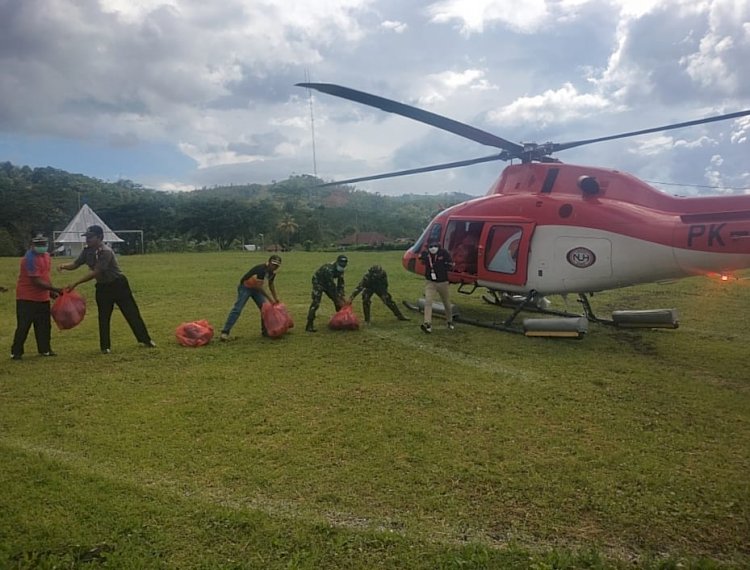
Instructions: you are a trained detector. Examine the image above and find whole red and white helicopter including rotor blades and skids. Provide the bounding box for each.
[297,83,750,338]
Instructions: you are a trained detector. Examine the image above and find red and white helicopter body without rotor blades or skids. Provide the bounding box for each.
[403,162,750,295]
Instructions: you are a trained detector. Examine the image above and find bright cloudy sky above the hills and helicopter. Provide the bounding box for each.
[0,0,750,195]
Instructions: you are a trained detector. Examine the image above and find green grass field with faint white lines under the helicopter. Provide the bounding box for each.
[0,252,750,569]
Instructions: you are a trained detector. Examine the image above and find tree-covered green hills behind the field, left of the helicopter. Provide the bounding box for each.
[0,162,473,255]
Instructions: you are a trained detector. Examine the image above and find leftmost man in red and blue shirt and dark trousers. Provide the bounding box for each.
[10,234,61,360]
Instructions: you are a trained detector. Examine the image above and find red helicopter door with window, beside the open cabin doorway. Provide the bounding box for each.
[479,222,535,285]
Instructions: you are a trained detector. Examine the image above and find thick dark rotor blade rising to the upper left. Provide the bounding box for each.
[297,83,524,160]
